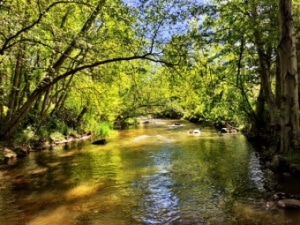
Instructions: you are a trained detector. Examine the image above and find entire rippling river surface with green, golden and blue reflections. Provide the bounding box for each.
[0,120,300,225]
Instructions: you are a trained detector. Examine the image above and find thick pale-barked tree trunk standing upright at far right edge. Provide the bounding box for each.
[278,0,299,153]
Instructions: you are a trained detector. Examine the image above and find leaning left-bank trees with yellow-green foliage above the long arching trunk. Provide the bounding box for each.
[0,0,173,139]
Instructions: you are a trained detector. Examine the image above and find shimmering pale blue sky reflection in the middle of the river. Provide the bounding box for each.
[135,149,179,224]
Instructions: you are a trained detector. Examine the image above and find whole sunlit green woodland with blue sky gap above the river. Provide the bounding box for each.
[0,0,300,158]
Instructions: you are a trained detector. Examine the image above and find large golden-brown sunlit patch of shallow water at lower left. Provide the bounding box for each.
[22,181,121,225]
